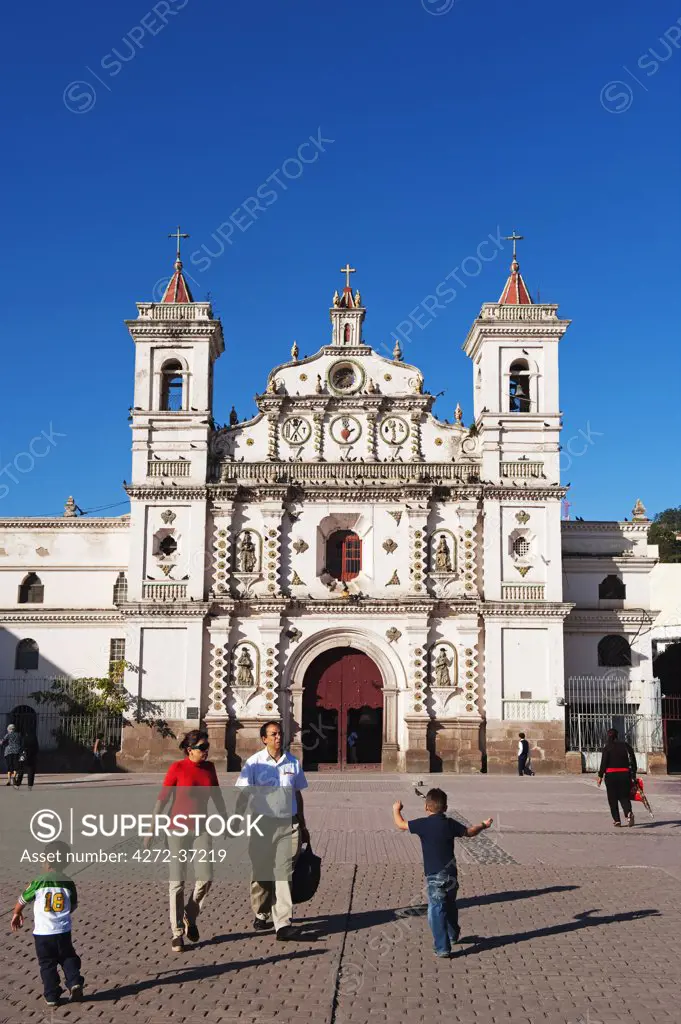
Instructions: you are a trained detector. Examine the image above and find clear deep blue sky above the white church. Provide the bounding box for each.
[0,0,681,519]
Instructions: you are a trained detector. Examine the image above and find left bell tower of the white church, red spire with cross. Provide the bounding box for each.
[122,228,224,742]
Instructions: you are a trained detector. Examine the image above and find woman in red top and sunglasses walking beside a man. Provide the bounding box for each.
[155,729,226,952]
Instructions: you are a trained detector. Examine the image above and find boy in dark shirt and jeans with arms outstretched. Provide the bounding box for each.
[392,790,493,957]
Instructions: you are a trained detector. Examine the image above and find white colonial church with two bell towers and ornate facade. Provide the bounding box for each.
[0,237,667,773]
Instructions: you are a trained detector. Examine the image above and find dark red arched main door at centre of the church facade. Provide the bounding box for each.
[300,647,383,770]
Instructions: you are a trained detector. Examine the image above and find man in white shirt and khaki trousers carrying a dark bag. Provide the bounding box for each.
[237,722,309,941]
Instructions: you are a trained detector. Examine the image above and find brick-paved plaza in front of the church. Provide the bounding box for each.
[0,773,681,1024]
